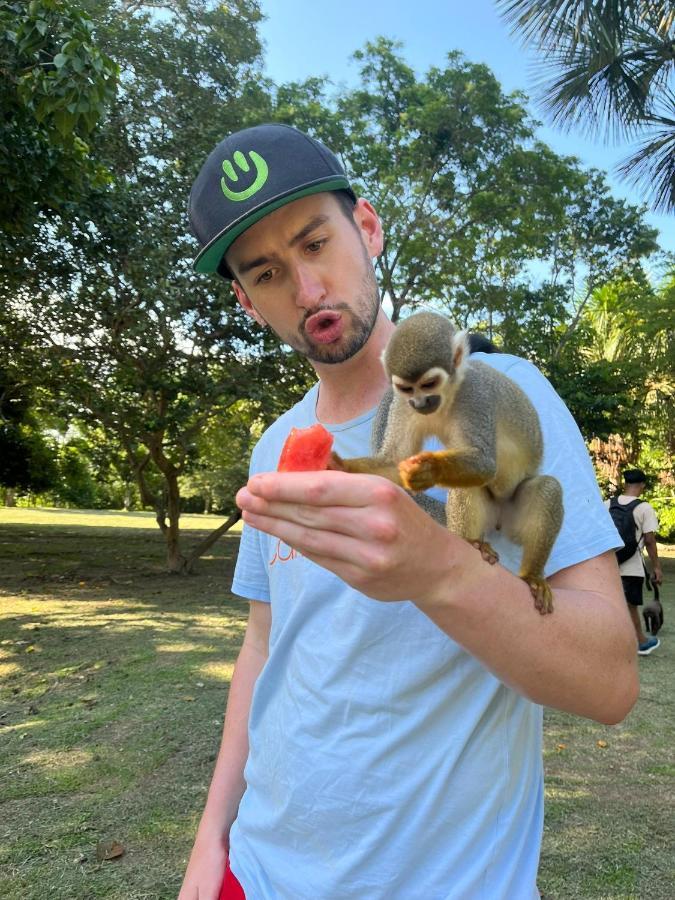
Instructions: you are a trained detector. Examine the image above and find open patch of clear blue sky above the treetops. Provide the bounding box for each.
[260,0,675,252]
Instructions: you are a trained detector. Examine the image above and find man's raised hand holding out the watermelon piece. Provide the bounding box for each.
[237,471,470,600]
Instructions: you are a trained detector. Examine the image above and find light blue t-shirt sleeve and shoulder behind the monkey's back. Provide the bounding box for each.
[504,357,622,576]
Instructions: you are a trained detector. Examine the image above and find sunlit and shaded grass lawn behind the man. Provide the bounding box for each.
[0,508,675,900]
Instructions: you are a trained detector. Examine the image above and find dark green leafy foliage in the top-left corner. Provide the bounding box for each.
[0,0,118,234]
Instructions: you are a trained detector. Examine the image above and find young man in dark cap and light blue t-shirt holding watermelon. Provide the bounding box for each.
[180,125,638,900]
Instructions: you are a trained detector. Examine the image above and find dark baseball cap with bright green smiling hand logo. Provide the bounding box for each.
[189,124,356,277]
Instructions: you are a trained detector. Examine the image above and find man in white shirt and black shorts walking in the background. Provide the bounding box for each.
[605,469,663,656]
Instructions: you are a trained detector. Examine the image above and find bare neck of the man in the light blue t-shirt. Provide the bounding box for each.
[315,310,395,425]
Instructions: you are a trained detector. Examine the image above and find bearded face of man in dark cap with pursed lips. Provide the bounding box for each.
[227,193,381,364]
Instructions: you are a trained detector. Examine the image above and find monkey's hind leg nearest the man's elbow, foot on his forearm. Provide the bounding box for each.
[503,475,563,615]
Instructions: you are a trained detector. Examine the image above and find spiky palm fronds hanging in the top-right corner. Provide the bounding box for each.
[497,0,675,212]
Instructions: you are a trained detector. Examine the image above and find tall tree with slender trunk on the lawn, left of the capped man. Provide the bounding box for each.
[5,0,280,571]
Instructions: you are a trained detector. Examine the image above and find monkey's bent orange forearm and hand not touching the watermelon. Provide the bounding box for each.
[398,447,495,491]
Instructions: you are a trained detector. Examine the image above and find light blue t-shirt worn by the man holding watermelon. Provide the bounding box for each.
[230,354,620,900]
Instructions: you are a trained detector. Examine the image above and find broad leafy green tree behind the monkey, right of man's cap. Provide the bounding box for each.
[270,38,657,348]
